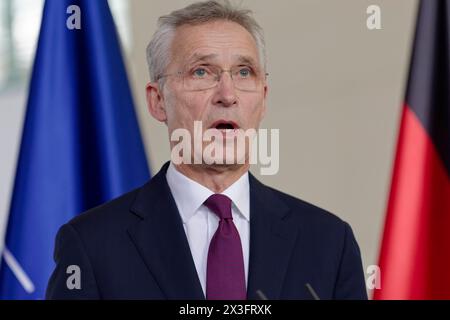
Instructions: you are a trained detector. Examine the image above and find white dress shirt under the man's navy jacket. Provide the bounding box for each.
[166,163,250,296]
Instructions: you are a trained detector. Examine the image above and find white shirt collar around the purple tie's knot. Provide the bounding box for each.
[166,162,250,223]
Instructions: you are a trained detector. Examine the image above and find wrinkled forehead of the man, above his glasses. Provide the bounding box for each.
[171,21,261,67]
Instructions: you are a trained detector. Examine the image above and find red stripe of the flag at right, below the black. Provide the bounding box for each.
[374,105,450,299]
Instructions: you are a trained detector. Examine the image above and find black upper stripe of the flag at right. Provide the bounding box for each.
[406,0,450,175]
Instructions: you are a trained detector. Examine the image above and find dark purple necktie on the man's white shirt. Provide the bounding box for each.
[205,194,247,300]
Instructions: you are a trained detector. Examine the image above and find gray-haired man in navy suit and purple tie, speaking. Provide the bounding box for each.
[47,1,367,300]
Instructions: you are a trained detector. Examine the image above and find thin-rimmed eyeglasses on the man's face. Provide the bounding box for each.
[157,65,269,92]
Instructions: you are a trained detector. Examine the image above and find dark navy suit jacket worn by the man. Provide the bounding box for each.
[46,163,367,300]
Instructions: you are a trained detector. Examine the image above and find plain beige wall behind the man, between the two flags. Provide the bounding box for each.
[127,0,417,278]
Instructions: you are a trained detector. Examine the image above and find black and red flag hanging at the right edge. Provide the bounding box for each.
[374,0,450,299]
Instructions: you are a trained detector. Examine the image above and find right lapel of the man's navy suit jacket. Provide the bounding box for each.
[247,175,298,300]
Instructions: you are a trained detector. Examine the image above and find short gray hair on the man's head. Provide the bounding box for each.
[147,0,266,82]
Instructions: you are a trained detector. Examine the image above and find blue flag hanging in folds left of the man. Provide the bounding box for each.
[0,0,150,299]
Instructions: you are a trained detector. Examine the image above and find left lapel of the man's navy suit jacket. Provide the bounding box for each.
[128,163,205,299]
